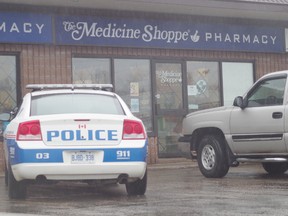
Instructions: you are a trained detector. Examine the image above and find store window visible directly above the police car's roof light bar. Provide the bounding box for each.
[72,58,111,84]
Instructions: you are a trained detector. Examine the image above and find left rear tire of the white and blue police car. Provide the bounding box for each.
[7,166,27,199]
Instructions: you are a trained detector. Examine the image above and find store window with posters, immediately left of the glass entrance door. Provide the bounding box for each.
[114,59,152,132]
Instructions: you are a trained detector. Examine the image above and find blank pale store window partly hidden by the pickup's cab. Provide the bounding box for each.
[222,62,254,106]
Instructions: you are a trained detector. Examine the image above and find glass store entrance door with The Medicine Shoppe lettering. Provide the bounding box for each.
[153,61,189,158]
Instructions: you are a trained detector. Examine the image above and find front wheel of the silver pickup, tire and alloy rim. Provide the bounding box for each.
[197,135,229,178]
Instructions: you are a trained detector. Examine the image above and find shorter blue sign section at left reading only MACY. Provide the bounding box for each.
[0,12,53,43]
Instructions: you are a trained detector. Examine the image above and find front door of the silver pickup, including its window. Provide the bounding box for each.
[230,75,287,155]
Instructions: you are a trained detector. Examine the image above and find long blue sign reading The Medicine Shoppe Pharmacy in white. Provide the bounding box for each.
[55,16,285,53]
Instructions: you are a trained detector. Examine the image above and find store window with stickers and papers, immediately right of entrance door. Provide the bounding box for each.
[186,61,221,112]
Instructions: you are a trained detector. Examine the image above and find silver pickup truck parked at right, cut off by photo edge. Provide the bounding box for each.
[179,71,288,178]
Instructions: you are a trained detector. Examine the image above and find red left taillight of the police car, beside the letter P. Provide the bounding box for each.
[16,120,42,141]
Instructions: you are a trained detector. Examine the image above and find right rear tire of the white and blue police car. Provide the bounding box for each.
[126,170,147,196]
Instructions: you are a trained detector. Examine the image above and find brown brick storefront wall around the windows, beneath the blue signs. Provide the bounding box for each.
[0,44,288,171]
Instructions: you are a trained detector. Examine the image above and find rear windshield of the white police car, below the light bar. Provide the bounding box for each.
[31,93,124,116]
